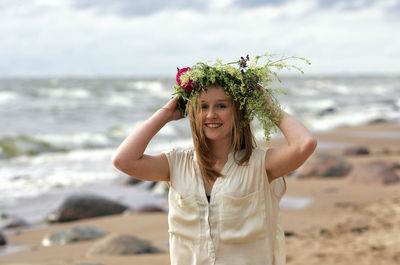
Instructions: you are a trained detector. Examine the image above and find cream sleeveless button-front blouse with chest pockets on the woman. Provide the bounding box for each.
[166,148,286,265]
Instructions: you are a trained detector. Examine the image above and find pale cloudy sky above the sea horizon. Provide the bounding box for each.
[0,0,400,78]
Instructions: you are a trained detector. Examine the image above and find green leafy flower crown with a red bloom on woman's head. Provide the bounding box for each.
[173,54,310,140]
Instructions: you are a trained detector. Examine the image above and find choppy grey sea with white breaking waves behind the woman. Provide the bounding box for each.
[0,75,400,227]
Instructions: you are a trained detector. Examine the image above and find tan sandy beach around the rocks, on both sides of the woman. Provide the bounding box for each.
[0,123,400,265]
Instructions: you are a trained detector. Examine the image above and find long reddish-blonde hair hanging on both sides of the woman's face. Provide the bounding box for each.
[187,85,256,180]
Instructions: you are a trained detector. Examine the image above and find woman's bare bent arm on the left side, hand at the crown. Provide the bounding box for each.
[113,97,182,181]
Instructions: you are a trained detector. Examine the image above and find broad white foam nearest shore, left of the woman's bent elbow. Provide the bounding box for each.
[0,149,116,200]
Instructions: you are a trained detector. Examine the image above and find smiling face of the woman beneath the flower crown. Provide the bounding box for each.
[199,86,233,141]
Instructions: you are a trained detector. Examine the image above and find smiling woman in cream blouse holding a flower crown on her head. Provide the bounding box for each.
[113,54,316,265]
